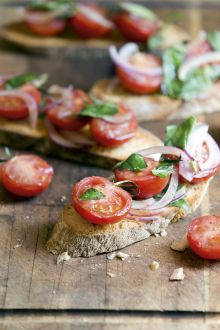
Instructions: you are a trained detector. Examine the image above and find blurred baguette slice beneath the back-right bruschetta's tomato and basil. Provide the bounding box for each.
[90,78,220,121]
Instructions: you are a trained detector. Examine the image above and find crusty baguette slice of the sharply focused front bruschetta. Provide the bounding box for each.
[46,181,209,257]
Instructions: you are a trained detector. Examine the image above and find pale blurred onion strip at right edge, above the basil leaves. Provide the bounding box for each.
[178,52,220,80]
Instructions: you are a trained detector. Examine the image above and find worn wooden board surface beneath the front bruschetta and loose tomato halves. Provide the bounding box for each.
[0,117,220,312]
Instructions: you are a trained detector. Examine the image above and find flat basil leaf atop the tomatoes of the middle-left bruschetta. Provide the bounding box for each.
[80,100,118,118]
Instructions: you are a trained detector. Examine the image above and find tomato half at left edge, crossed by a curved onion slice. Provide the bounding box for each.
[0,85,41,120]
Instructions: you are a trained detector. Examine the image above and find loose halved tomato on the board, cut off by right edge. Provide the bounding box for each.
[187,215,220,260]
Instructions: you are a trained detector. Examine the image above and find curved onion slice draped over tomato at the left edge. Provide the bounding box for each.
[0,89,38,128]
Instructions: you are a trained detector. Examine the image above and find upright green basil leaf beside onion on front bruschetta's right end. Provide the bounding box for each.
[165,116,196,149]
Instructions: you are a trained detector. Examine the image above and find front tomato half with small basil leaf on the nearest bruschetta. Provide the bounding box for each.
[72,176,132,225]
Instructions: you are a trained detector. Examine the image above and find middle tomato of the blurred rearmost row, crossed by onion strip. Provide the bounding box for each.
[71,5,113,39]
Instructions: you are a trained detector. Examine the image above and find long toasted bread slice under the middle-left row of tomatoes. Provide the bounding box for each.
[0,119,162,168]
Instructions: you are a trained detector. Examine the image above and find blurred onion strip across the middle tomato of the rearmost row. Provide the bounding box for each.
[76,4,115,29]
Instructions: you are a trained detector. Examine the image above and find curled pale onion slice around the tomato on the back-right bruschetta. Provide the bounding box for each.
[109,42,163,76]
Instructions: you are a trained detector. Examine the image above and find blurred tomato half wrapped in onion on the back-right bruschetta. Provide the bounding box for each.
[116,53,162,94]
